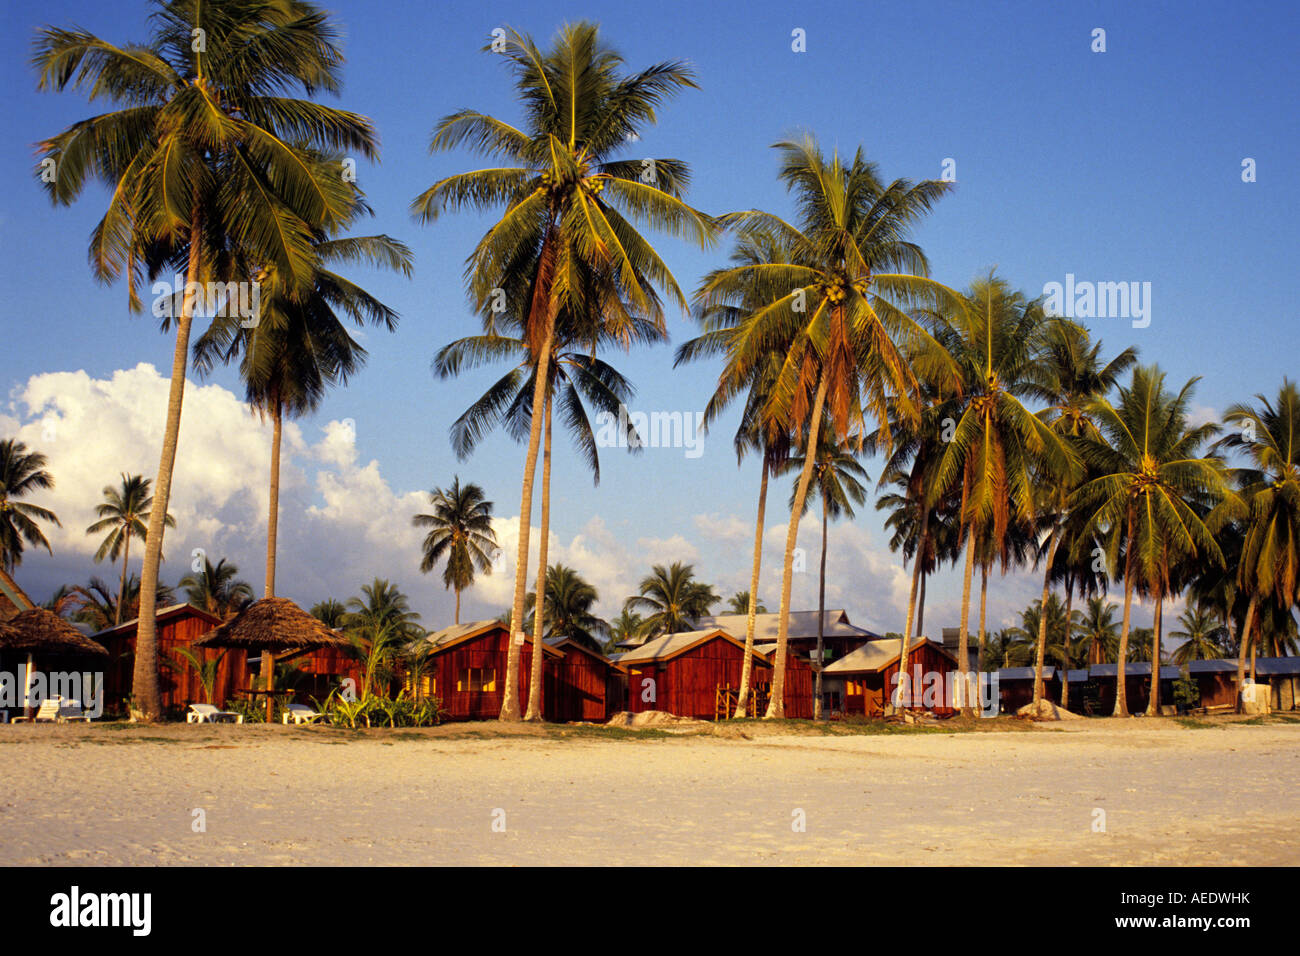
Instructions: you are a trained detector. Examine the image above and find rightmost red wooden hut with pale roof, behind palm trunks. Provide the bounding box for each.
[823,637,957,717]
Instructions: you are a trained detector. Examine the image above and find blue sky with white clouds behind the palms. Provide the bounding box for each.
[0,0,1300,639]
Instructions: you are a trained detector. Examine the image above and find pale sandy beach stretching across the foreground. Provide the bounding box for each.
[0,718,1300,865]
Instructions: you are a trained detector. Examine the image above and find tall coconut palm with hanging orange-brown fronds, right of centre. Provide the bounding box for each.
[696,138,953,718]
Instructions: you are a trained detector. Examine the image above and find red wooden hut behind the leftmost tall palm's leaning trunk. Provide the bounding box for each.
[94,604,241,717]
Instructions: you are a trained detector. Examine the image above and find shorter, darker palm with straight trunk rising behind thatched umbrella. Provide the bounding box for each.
[194,235,411,597]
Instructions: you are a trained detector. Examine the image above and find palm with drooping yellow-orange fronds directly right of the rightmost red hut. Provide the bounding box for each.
[932,272,1078,714]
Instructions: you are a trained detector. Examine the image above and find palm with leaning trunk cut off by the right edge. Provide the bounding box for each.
[1218,380,1300,707]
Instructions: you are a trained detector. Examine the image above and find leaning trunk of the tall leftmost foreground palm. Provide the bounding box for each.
[131,206,203,723]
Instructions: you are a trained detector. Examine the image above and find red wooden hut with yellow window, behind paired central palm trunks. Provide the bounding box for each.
[421,620,566,721]
